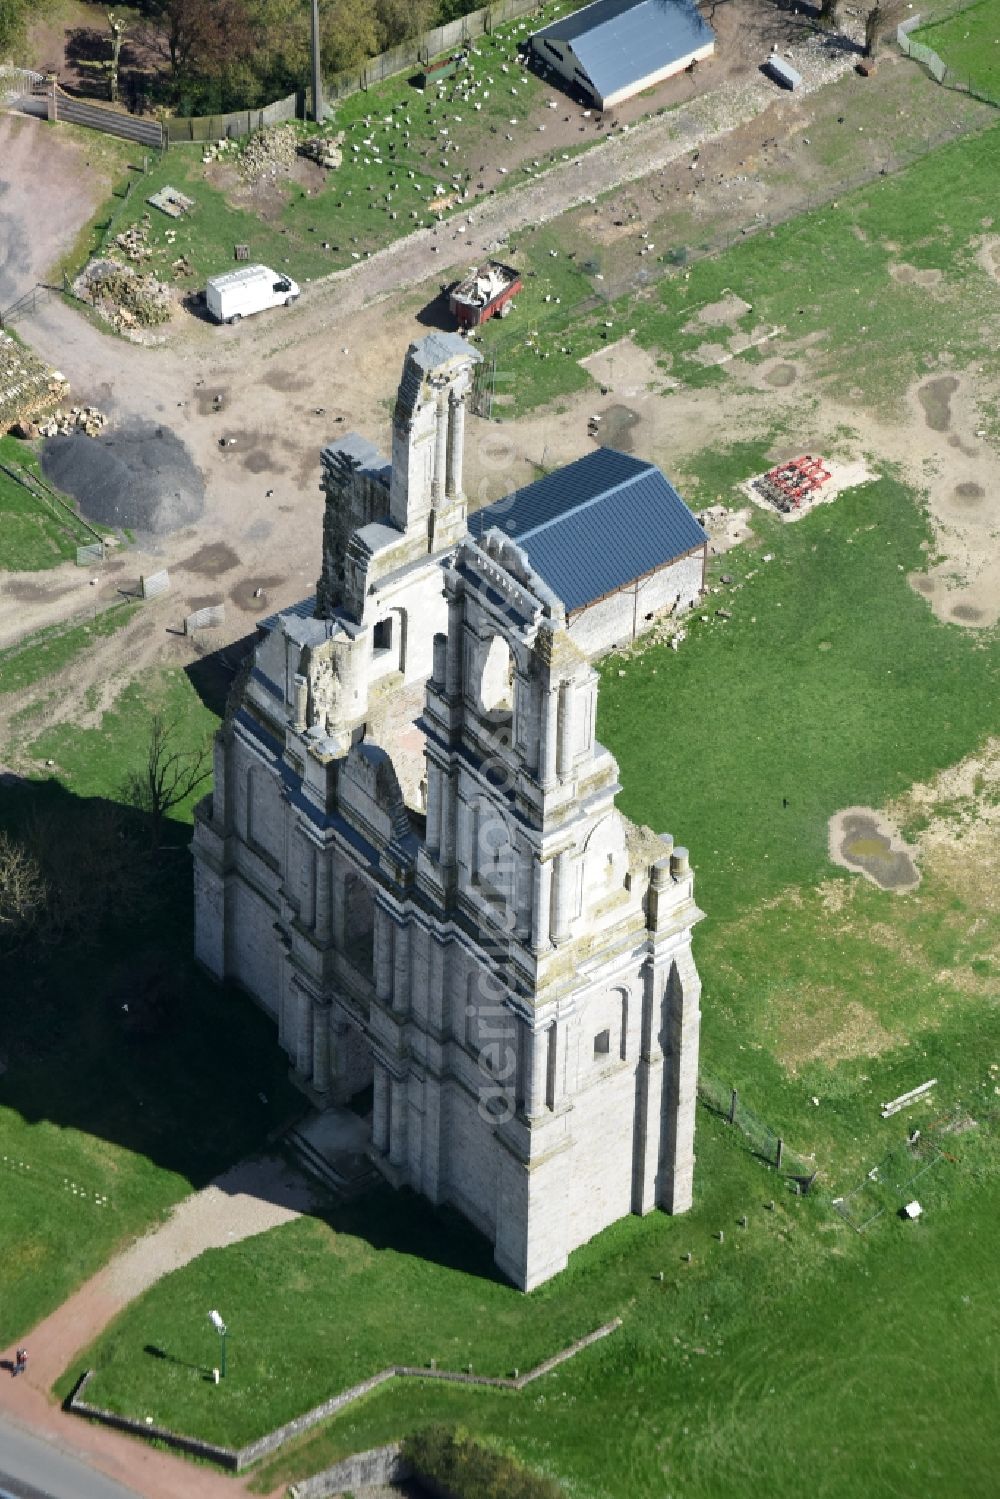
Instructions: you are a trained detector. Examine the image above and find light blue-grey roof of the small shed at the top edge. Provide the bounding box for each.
[532,0,715,99]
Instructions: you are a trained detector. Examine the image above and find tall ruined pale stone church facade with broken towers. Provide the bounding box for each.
[195,334,700,1289]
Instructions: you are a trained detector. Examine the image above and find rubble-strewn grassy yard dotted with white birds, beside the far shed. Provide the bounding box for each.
[60,3,881,307]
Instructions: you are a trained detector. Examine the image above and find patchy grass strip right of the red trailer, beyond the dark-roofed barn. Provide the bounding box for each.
[481,113,1000,423]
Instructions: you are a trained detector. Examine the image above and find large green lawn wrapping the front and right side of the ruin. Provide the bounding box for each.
[60,473,1000,1499]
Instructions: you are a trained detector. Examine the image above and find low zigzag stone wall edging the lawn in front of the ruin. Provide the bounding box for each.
[66,1316,622,1469]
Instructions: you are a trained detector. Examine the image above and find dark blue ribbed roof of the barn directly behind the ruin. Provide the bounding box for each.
[469,448,708,612]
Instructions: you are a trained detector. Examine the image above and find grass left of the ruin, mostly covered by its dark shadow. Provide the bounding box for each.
[0,673,297,1345]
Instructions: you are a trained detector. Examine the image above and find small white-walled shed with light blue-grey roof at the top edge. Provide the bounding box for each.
[531,0,715,109]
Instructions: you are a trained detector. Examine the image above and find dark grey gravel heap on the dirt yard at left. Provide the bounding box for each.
[42,421,205,537]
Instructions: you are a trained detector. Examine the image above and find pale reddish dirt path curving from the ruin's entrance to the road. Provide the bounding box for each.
[0,1157,313,1499]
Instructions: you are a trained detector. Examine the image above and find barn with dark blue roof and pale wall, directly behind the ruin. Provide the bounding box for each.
[469,448,708,655]
